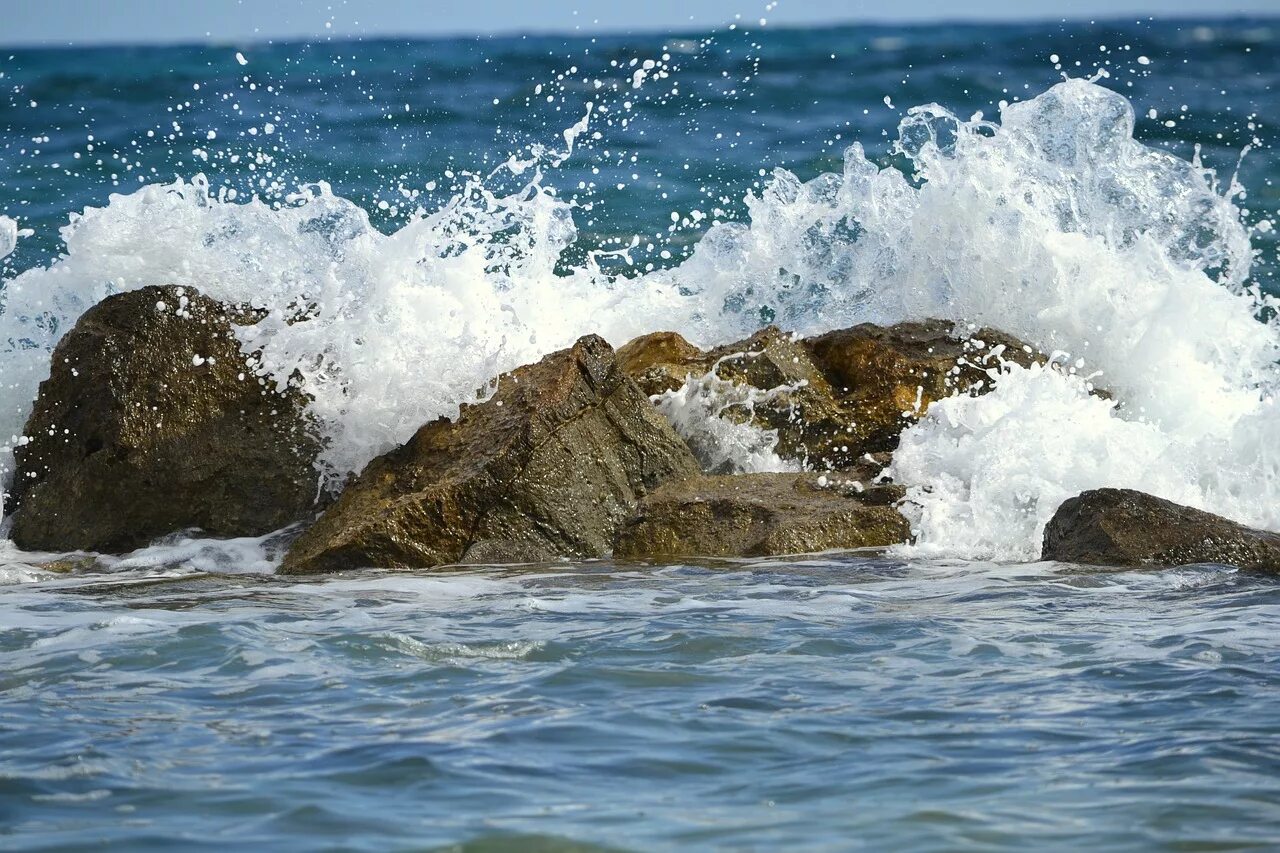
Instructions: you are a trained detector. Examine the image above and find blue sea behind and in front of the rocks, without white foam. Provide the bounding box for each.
[0,20,1280,850]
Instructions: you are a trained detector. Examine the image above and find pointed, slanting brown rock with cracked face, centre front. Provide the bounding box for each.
[280,336,698,574]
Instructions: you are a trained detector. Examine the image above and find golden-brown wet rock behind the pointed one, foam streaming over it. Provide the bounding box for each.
[618,320,1046,470]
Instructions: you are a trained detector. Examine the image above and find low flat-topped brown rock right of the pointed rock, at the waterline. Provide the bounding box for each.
[614,474,911,560]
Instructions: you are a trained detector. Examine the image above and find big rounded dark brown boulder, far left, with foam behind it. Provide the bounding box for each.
[10,287,320,552]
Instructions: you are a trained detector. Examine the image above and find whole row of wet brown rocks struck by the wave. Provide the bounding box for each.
[8,287,1280,574]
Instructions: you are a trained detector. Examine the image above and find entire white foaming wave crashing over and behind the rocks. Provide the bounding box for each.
[0,81,1280,558]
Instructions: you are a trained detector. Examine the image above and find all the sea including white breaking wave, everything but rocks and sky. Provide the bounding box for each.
[0,19,1280,850]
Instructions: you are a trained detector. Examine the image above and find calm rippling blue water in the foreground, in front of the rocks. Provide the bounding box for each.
[0,557,1280,850]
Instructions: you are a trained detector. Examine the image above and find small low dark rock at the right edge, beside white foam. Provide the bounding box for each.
[1042,489,1280,573]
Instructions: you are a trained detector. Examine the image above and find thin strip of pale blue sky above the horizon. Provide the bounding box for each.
[0,0,1280,45]
